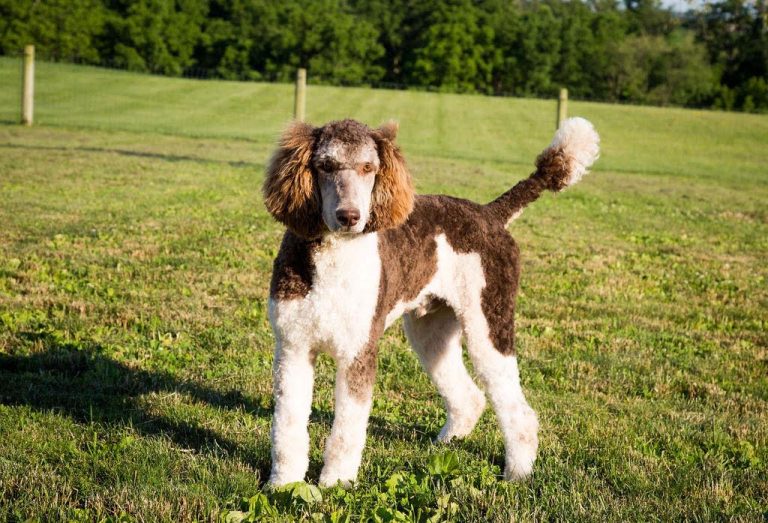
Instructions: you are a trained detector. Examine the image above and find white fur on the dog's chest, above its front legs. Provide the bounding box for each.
[269,233,381,359]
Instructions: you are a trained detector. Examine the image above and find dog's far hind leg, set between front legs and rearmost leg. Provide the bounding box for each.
[404,305,485,441]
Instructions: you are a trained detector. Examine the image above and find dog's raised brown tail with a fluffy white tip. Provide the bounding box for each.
[487,118,600,225]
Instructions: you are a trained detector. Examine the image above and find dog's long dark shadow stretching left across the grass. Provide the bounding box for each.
[0,332,429,482]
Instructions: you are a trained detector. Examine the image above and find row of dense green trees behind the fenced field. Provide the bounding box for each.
[0,0,768,111]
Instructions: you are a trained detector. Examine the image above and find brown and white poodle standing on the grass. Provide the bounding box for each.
[264,118,599,486]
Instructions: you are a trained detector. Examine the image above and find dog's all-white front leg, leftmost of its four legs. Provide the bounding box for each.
[269,339,315,486]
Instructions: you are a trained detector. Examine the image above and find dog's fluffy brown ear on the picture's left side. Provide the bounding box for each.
[262,122,323,239]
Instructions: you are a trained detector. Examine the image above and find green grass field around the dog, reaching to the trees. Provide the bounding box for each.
[0,59,768,521]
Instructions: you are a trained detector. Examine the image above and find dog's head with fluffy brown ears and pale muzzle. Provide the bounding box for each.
[263,120,413,238]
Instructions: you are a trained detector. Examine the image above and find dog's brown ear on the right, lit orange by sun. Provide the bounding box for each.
[365,122,414,231]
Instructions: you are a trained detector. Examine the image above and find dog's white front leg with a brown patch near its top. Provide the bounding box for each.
[320,344,376,486]
